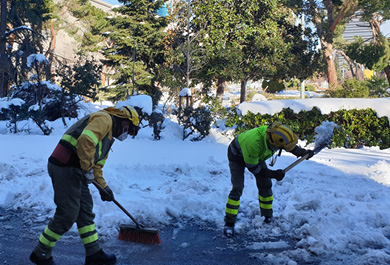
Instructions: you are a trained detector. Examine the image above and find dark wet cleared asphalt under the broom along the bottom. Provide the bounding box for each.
[0,208,308,265]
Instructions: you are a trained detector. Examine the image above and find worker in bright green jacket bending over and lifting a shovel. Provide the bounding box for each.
[224,122,314,237]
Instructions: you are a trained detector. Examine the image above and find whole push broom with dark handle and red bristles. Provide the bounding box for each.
[92,180,161,244]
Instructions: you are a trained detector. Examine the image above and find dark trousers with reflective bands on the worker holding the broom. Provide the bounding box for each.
[34,162,101,259]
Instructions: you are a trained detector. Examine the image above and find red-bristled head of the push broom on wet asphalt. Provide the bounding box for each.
[118,225,161,244]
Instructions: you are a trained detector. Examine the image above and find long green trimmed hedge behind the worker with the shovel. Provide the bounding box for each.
[226,107,390,149]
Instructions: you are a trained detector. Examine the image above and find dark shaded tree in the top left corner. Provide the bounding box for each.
[0,0,53,97]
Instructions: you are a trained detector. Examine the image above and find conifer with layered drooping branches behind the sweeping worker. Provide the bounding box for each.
[100,0,167,102]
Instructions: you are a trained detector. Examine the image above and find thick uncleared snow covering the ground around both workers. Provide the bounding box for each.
[0,98,390,265]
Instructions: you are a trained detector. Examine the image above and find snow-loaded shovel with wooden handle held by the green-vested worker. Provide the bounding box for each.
[284,121,337,172]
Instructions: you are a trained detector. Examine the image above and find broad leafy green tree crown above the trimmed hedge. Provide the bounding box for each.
[187,0,320,100]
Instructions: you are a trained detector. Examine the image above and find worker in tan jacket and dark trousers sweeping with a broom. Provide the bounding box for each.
[30,106,139,265]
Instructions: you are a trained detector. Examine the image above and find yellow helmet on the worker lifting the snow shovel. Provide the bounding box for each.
[267,122,298,151]
